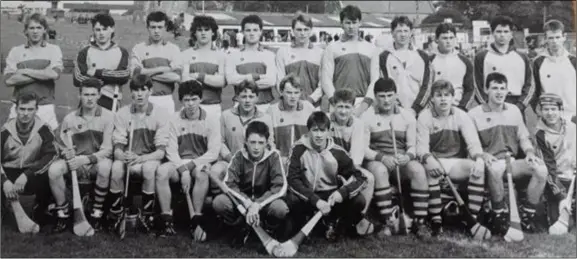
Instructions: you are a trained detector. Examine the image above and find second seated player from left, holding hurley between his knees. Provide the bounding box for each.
[48,79,114,233]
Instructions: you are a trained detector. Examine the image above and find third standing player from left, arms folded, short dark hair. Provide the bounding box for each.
[130,11,181,114]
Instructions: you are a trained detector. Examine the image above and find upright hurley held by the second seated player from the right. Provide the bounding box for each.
[504,153,524,242]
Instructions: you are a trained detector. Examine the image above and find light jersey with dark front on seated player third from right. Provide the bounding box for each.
[417,107,483,161]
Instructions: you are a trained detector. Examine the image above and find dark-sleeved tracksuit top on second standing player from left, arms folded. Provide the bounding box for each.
[73,42,130,99]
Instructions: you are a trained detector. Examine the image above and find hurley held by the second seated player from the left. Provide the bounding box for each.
[64,129,94,236]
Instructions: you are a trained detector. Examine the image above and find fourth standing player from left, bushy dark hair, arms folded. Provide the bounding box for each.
[181,16,227,119]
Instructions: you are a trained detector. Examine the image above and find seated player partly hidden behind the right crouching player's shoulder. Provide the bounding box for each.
[330,89,375,235]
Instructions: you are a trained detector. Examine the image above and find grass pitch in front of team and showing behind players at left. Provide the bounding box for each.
[0,17,577,258]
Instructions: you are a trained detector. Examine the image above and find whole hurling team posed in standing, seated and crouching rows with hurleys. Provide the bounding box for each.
[0,5,577,257]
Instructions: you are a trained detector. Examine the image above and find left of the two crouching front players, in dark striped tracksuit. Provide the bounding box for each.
[212,121,289,244]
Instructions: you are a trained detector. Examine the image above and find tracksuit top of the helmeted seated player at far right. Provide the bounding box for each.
[535,120,577,179]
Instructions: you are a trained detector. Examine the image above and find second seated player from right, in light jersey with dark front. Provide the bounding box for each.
[469,72,547,234]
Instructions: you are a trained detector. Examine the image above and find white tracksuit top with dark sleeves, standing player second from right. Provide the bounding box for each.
[474,43,536,111]
